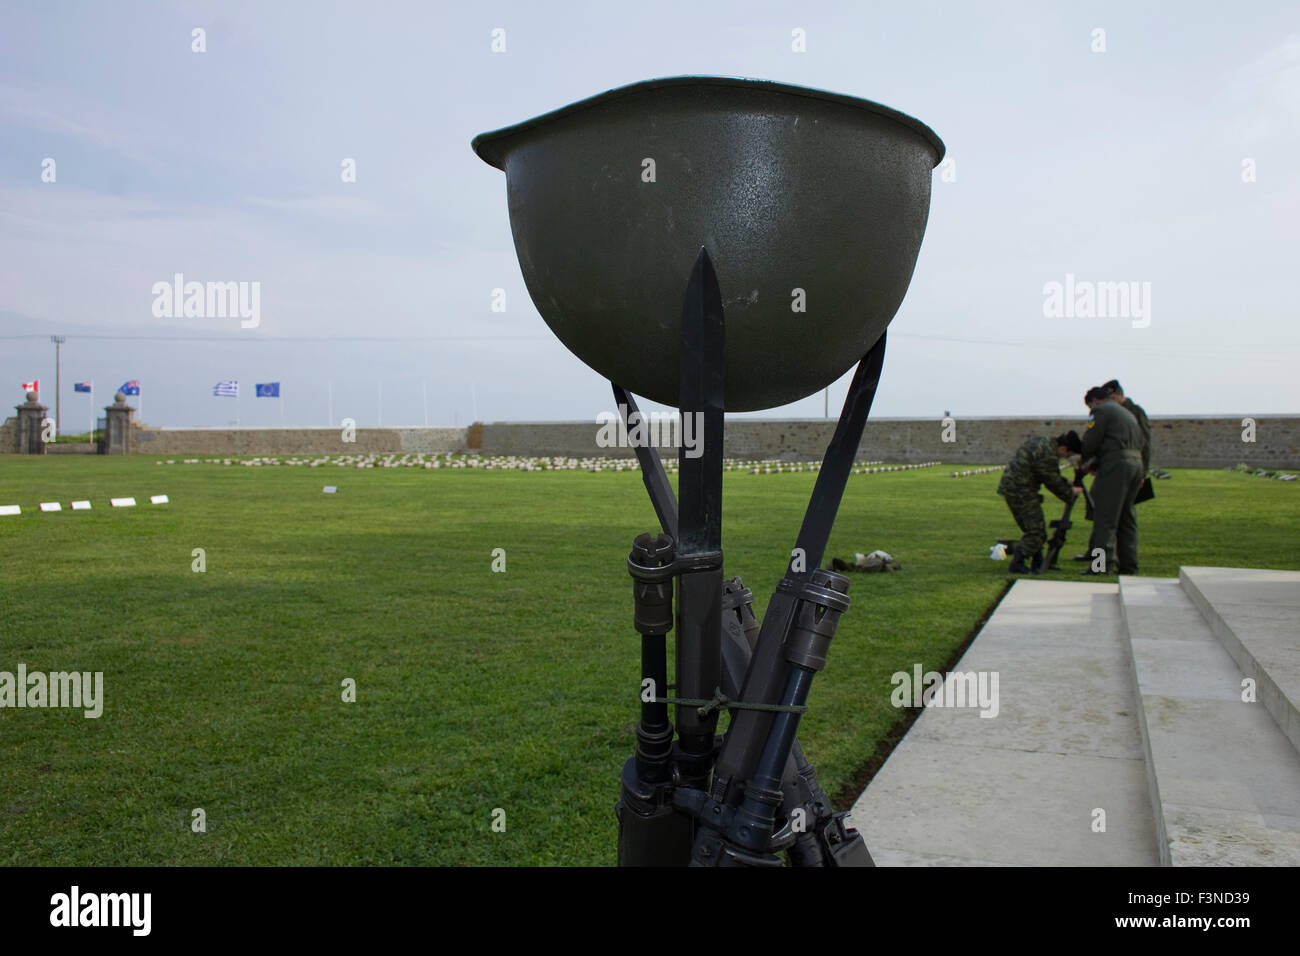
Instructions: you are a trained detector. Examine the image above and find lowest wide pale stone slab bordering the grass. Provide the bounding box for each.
[852,580,1160,866]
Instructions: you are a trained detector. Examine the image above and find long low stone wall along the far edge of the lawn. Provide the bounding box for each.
[0,415,1300,471]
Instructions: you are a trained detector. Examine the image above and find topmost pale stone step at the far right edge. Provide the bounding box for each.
[1179,567,1300,750]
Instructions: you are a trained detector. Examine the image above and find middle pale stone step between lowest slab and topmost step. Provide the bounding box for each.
[1119,578,1300,866]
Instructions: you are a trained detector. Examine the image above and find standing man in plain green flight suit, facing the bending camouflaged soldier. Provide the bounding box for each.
[1083,388,1144,575]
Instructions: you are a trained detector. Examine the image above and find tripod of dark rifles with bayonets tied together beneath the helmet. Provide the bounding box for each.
[614,250,885,866]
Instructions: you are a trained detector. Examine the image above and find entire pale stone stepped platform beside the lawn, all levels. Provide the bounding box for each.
[852,568,1300,866]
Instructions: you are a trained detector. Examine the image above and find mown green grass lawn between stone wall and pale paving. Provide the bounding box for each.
[0,455,1300,865]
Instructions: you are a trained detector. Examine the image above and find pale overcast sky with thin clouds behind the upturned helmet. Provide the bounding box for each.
[0,0,1300,432]
